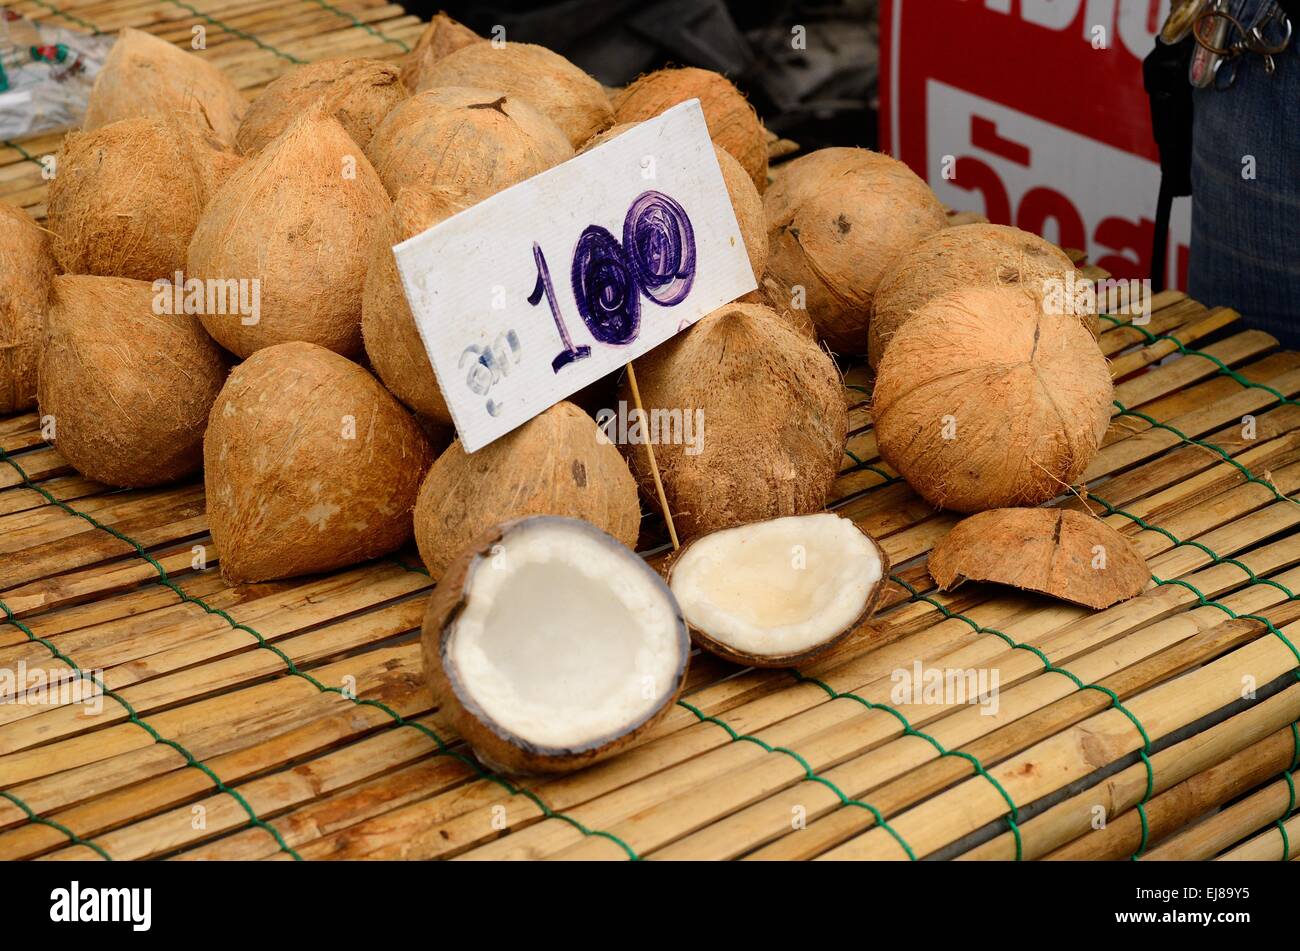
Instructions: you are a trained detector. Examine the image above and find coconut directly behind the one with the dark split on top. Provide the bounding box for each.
[417,43,614,148]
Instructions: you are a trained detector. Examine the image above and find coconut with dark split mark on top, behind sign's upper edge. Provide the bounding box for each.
[367,87,573,200]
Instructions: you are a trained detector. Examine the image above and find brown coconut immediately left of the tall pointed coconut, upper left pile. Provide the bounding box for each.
[48,113,243,281]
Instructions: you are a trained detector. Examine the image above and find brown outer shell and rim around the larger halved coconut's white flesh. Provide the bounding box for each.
[420,516,690,776]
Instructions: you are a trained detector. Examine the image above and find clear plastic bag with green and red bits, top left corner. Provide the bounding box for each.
[0,6,114,139]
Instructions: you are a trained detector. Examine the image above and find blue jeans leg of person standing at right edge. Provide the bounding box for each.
[1188,0,1300,348]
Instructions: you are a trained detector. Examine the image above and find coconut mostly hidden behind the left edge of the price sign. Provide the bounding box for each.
[361,184,469,426]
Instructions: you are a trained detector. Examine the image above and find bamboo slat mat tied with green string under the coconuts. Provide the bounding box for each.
[0,0,1300,860]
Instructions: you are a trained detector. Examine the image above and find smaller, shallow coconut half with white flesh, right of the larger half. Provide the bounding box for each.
[668,512,889,666]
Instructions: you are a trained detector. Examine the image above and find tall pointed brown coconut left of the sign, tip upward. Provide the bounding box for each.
[186,103,390,356]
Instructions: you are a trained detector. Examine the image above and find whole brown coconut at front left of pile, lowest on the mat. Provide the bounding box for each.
[203,343,433,582]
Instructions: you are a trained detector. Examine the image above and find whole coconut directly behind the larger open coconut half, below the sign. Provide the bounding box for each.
[415,403,641,579]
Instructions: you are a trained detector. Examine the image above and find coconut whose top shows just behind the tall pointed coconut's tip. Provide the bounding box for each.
[235,58,407,155]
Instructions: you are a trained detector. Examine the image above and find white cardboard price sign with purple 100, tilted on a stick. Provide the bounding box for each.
[393,99,755,452]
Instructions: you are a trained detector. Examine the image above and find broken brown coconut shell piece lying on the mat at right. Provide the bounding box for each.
[930,508,1151,611]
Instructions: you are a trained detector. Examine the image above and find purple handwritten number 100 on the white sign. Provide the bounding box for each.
[528,191,696,373]
